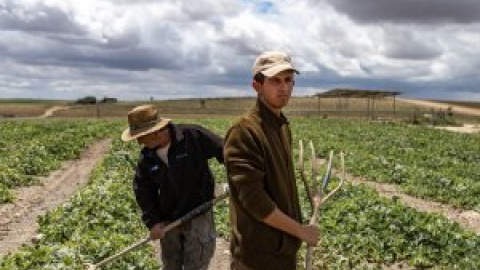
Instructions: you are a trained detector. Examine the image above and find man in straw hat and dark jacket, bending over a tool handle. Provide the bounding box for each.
[122,105,223,270]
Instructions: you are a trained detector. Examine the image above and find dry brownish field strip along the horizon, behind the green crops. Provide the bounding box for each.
[0,97,480,123]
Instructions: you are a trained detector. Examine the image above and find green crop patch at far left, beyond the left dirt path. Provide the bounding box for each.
[0,120,119,204]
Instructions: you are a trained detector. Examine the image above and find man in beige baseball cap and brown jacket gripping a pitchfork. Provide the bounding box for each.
[224,52,319,270]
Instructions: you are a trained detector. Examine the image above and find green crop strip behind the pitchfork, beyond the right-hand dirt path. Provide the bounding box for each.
[294,120,480,212]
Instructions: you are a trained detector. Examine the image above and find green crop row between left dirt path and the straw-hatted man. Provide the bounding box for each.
[0,139,158,270]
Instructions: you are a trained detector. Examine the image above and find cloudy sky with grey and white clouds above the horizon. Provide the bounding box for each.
[0,0,480,101]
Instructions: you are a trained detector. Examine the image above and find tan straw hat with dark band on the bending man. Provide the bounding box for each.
[122,105,171,142]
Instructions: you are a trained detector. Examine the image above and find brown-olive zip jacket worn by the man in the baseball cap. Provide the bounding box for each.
[224,100,302,270]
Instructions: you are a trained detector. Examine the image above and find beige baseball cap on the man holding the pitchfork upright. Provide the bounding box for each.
[253,52,300,77]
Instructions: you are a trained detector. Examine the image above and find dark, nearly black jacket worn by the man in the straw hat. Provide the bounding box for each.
[133,124,223,229]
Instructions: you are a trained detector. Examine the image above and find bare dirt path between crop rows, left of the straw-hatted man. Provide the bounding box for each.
[0,139,111,257]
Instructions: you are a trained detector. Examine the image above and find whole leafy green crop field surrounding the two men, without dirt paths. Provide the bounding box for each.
[0,118,480,270]
